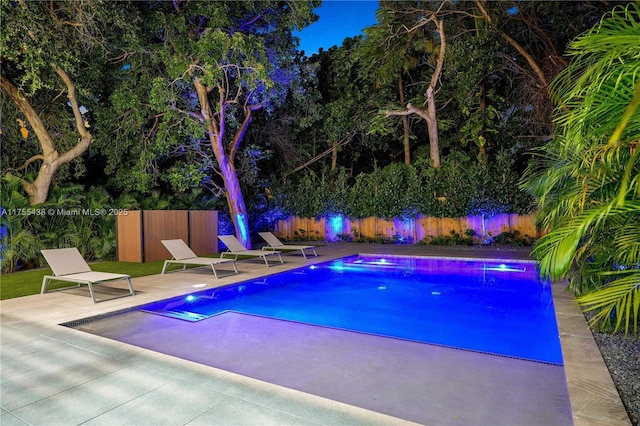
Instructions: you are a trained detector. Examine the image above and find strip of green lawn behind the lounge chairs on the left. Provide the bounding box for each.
[0,256,251,300]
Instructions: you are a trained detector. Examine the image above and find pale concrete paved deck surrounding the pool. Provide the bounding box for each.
[0,244,630,426]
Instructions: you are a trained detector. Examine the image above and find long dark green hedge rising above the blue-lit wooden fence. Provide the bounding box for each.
[273,154,532,219]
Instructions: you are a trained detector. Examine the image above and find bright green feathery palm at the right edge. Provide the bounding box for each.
[523,3,640,334]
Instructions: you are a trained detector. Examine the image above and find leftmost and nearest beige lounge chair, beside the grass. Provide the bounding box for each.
[40,247,135,303]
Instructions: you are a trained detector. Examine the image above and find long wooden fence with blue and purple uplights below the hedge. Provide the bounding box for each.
[274,214,542,242]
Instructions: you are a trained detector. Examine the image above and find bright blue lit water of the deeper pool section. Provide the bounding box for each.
[141,255,562,365]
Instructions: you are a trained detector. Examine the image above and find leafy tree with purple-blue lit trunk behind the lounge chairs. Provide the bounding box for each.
[142,1,316,247]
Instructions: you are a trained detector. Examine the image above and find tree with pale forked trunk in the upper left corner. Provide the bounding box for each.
[0,0,140,205]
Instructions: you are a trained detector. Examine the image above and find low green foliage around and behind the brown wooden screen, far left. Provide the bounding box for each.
[0,179,221,272]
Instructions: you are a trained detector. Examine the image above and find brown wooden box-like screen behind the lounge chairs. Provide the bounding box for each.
[117,210,218,262]
